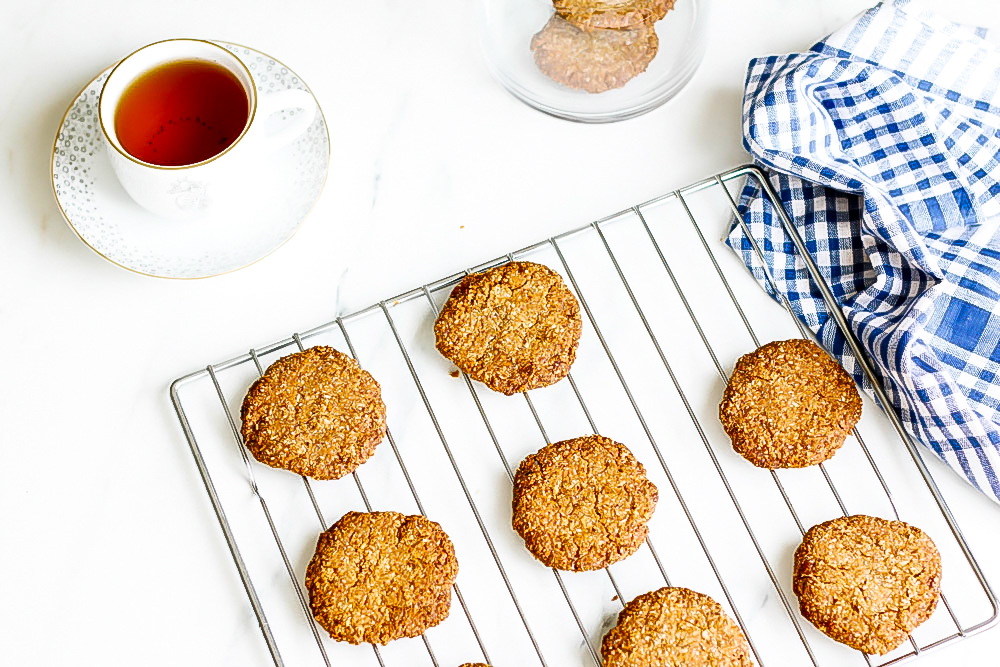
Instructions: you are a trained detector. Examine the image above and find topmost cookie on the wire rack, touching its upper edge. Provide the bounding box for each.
[434,262,583,396]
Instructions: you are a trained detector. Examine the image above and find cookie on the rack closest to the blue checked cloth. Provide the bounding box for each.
[719,339,861,470]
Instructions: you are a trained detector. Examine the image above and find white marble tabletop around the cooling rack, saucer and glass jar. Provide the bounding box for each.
[0,0,1000,667]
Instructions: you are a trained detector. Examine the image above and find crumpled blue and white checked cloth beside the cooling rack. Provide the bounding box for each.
[727,0,1000,501]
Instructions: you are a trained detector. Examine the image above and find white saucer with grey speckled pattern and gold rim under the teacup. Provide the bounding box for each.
[52,42,330,278]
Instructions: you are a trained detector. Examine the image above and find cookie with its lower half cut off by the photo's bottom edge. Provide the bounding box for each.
[601,588,753,667]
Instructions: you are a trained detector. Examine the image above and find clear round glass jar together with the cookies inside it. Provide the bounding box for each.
[479,0,709,123]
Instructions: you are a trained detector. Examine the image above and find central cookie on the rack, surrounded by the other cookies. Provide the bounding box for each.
[513,435,658,572]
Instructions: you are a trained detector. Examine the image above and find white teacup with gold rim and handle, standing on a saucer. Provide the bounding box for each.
[98,39,317,218]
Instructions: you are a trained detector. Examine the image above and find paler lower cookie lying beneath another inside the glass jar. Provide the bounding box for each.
[531,14,660,93]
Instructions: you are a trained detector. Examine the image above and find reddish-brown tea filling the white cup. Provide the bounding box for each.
[115,60,250,167]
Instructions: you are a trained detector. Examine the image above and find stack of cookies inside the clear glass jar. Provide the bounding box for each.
[531,0,674,93]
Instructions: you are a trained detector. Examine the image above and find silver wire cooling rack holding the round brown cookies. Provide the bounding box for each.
[171,167,998,667]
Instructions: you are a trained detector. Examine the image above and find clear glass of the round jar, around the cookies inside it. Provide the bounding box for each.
[479,0,709,123]
